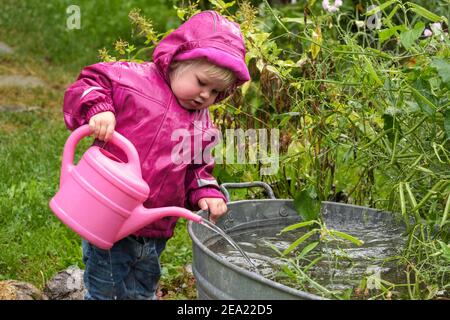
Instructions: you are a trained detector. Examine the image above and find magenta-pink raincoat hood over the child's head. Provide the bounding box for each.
[153,11,250,98]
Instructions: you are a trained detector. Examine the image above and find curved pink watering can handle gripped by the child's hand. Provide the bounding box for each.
[60,124,141,186]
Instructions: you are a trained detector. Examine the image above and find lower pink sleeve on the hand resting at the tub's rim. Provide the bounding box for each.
[186,162,227,210]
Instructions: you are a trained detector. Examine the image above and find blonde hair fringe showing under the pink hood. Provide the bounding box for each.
[169,59,236,91]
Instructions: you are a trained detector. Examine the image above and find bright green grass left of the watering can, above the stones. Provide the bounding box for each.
[0,111,81,287]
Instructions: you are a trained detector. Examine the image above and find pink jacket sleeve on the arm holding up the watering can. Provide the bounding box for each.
[63,62,120,130]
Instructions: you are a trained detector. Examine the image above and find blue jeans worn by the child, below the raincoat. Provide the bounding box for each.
[83,236,167,300]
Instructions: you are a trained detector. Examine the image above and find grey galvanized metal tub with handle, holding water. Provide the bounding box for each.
[188,182,401,300]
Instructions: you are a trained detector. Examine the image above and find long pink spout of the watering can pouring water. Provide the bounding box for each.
[116,205,203,241]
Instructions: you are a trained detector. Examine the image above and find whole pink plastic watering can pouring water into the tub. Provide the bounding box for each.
[50,125,202,249]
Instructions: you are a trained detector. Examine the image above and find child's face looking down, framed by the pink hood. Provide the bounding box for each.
[170,64,225,110]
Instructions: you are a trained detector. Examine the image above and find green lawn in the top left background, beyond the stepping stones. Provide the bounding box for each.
[0,0,179,72]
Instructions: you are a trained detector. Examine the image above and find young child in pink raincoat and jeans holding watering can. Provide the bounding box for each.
[63,11,250,299]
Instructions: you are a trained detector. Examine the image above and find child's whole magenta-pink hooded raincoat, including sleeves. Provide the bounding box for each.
[63,11,250,238]
